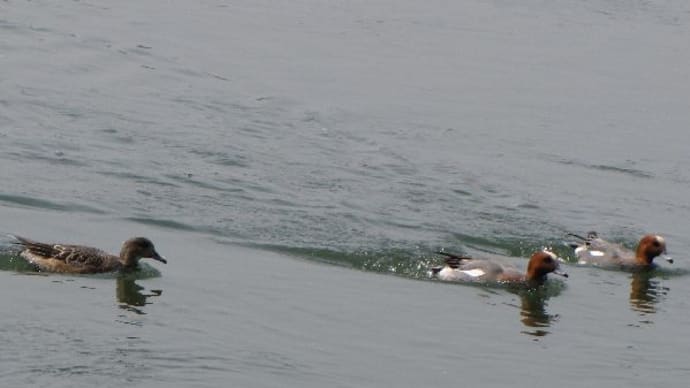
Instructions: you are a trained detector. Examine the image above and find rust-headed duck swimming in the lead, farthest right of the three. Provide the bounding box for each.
[567,231,673,269]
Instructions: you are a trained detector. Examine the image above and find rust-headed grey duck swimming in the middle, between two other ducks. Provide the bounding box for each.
[430,249,568,287]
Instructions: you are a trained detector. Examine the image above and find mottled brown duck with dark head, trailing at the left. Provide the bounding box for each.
[12,235,168,274]
